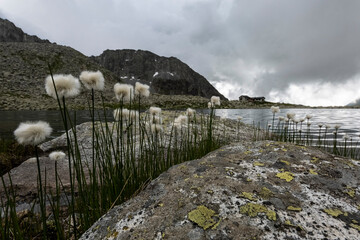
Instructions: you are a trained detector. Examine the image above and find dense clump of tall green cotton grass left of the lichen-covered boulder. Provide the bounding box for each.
[0,66,225,239]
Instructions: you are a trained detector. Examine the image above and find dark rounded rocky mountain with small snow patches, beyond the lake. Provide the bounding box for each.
[92,49,226,100]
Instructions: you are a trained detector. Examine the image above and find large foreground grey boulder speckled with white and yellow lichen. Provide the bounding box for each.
[81,141,360,240]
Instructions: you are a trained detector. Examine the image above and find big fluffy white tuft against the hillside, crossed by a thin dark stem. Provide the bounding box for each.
[45,74,80,99]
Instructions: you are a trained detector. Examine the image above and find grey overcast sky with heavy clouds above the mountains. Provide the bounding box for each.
[0,0,360,106]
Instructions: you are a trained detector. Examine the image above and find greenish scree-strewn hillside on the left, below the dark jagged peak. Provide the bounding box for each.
[0,42,119,110]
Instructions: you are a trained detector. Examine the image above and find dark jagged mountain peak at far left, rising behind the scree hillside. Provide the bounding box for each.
[0,18,50,43]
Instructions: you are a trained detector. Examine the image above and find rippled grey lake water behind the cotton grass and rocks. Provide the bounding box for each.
[0,109,360,140]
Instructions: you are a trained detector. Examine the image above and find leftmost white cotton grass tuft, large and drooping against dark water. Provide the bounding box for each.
[14,121,52,146]
